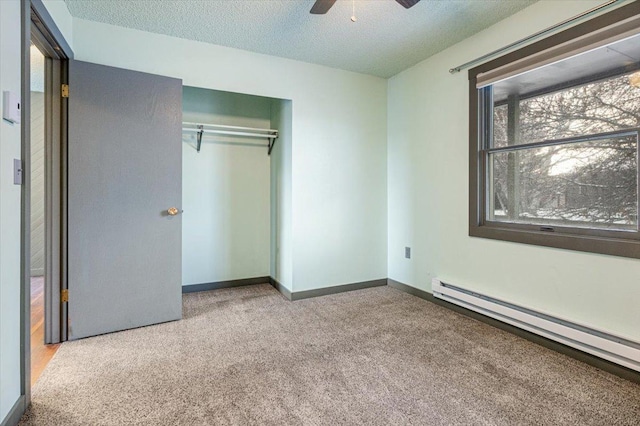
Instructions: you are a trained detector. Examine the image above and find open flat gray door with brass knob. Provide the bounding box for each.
[68,61,182,340]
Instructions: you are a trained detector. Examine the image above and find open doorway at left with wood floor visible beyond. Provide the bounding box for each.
[21,2,71,392]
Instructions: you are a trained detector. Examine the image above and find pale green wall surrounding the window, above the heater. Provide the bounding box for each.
[388,1,640,340]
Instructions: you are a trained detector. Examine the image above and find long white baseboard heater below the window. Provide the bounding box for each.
[431,279,640,371]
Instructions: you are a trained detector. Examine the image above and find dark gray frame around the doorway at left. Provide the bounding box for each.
[20,0,73,411]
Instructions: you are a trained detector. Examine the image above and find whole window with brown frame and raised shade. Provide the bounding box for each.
[469,4,640,258]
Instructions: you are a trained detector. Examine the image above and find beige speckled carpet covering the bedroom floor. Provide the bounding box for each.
[21,285,640,426]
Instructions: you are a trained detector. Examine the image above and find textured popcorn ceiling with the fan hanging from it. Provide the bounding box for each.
[65,0,536,77]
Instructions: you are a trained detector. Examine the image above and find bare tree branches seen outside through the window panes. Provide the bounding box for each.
[488,71,640,230]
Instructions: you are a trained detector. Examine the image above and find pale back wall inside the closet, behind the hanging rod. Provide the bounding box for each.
[182,87,272,285]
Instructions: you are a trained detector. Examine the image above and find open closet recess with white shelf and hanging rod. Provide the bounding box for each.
[182,86,292,293]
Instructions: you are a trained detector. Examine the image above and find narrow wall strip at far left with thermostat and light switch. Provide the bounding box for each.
[0,0,21,422]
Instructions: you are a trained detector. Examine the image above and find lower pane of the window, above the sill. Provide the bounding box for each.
[488,135,638,230]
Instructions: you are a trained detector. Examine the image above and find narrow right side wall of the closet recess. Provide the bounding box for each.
[271,99,293,291]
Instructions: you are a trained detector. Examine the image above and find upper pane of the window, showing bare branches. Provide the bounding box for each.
[493,71,640,147]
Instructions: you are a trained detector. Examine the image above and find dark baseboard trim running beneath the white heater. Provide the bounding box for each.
[387,278,640,384]
